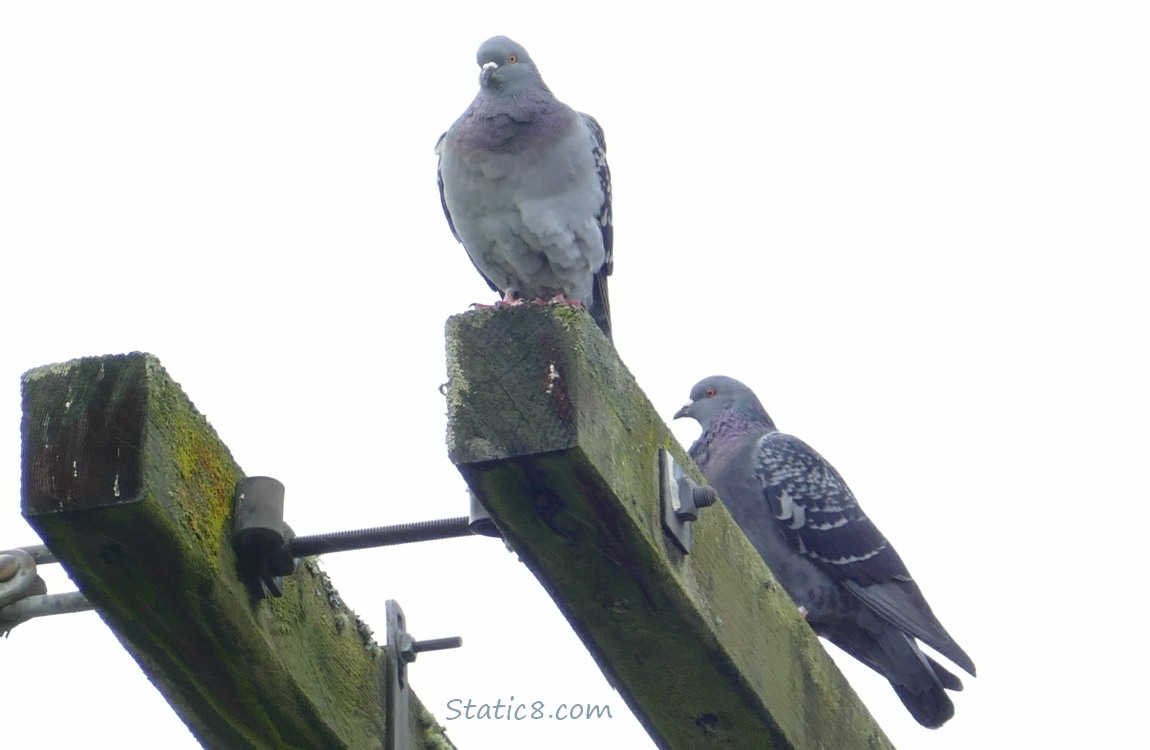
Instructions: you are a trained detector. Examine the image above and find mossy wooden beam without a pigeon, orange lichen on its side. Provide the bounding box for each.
[23,353,452,750]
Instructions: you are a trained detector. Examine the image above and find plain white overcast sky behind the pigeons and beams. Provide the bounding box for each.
[0,0,1150,750]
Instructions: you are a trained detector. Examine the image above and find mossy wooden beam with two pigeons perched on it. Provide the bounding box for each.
[447,305,891,750]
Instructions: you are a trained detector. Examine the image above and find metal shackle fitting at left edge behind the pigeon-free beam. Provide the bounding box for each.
[0,544,95,636]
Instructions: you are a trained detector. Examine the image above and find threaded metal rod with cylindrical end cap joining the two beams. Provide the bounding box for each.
[231,476,498,596]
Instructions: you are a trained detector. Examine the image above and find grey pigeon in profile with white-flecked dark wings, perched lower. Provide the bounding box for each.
[675,376,974,728]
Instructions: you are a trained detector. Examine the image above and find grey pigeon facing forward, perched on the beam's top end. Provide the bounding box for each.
[436,37,612,337]
